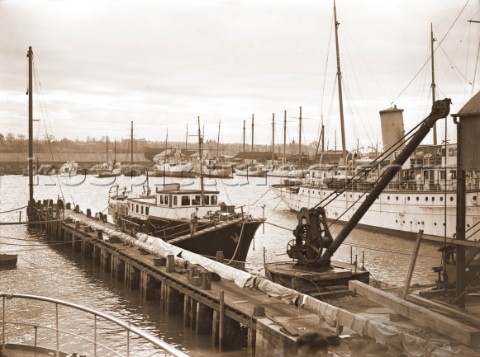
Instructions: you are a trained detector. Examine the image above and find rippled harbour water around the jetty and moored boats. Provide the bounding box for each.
[0,176,440,356]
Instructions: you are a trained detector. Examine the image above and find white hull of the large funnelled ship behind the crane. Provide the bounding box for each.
[272,185,480,239]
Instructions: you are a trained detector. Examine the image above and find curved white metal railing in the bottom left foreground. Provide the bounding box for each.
[0,293,188,357]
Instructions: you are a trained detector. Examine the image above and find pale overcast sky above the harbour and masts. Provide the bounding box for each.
[0,0,480,148]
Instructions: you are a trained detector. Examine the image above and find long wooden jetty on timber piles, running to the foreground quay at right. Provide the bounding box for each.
[31,200,480,357]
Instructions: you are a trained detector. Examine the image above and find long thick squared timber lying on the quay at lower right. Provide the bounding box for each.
[348,280,480,347]
